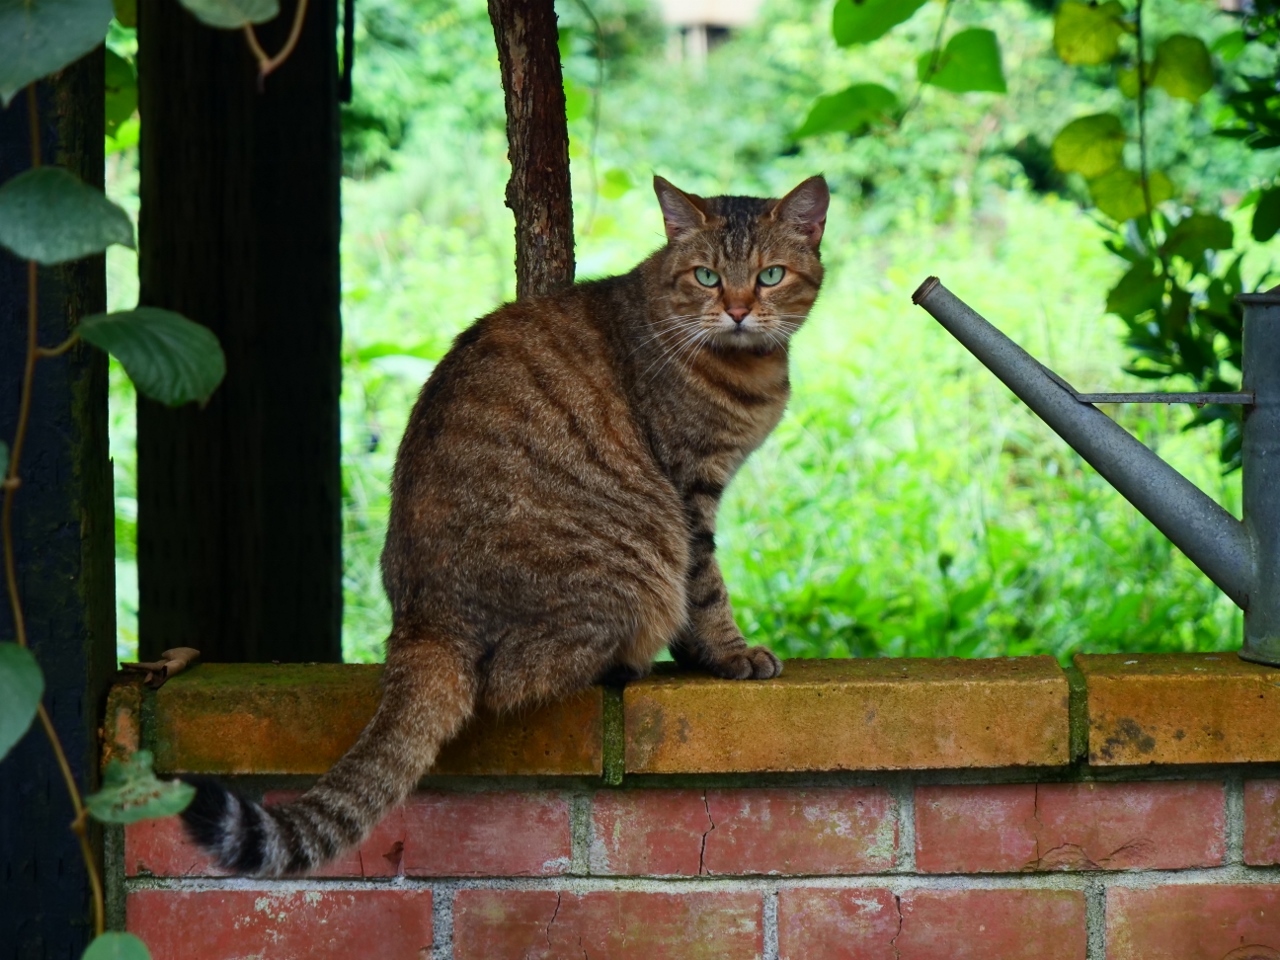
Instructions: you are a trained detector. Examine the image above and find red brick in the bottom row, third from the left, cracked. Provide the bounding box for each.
[778,887,1087,960]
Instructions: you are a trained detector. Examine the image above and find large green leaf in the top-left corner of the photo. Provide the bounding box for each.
[0,0,111,106]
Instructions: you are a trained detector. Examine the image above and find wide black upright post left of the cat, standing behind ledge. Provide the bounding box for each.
[138,0,342,660]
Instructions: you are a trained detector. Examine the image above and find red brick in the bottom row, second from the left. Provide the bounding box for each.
[453,890,762,960]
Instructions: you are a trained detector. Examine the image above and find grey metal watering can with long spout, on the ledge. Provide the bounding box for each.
[911,276,1280,667]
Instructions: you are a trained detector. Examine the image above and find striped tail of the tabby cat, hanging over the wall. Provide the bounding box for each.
[182,634,476,877]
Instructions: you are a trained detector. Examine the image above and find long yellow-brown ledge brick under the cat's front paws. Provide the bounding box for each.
[623,657,1070,773]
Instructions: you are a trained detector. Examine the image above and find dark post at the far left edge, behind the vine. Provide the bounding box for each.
[0,56,115,960]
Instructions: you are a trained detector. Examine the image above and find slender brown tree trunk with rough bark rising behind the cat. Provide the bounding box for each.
[489,0,573,297]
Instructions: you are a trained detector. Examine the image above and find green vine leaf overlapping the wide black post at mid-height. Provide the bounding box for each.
[77,307,227,407]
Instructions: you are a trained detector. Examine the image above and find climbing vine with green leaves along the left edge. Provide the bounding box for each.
[0,0,294,960]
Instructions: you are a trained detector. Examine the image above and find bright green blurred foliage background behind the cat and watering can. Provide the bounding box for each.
[111,0,1274,660]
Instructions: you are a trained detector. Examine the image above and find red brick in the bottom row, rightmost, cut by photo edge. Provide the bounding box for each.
[1107,884,1280,960]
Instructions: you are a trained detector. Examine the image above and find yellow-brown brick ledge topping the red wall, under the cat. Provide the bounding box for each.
[104,653,1280,782]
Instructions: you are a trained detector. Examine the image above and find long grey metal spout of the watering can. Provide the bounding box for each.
[911,276,1254,616]
